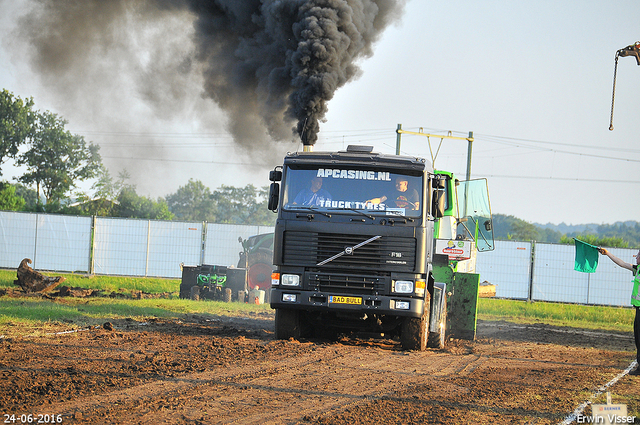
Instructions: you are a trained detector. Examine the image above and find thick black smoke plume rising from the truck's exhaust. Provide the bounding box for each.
[15,0,406,149]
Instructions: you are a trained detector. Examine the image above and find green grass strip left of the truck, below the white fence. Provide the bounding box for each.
[0,270,273,336]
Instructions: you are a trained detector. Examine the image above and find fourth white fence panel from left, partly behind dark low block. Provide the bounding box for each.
[146,221,203,278]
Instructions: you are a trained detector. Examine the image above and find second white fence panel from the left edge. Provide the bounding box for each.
[33,214,92,272]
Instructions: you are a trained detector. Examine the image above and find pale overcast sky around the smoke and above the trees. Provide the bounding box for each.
[0,0,640,224]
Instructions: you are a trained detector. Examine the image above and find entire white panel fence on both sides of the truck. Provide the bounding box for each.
[0,211,637,306]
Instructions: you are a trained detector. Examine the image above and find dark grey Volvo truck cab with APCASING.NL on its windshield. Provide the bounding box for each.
[269,146,446,350]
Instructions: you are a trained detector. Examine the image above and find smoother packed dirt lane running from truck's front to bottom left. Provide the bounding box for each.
[28,345,478,424]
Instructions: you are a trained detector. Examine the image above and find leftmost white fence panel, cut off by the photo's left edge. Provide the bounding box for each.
[0,211,37,269]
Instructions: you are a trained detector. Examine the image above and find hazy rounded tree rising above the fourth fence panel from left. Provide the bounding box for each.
[165,179,217,221]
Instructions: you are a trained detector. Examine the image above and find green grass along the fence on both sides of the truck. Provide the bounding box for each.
[0,270,635,335]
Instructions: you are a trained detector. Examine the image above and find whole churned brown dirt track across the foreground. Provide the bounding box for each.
[13,323,627,424]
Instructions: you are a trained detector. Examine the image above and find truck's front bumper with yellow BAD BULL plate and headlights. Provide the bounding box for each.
[271,287,424,317]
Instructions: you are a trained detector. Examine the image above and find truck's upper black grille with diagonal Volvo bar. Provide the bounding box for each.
[283,231,416,272]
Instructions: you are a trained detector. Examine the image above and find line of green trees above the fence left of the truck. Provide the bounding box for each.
[0,89,275,225]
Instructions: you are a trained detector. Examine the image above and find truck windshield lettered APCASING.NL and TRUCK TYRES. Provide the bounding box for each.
[282,167,423,217]
